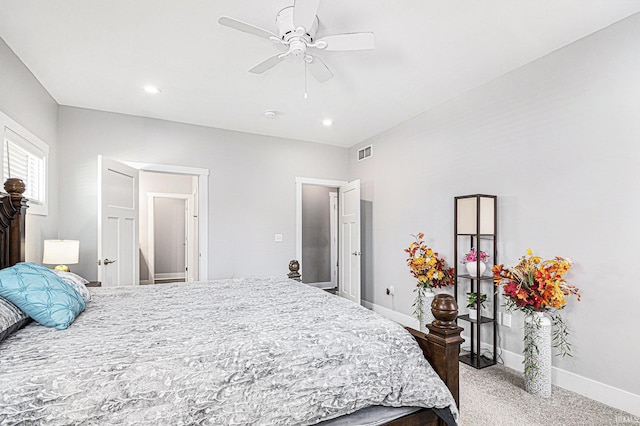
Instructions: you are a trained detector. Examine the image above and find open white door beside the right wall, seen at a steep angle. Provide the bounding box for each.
[338,180,362,304]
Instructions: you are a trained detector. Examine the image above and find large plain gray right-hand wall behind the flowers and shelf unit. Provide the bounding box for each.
[350,14,640,395]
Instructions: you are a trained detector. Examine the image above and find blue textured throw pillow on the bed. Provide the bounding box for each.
[0,262,86,330]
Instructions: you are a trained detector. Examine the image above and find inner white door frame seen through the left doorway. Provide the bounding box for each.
[147,192,195,284]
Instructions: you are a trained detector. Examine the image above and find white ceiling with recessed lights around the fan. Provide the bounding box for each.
[0,0,640,147]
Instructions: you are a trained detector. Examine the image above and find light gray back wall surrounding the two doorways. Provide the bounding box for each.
[59,107,348,279]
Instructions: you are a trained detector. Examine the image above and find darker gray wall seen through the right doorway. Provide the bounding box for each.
[302,185,338,283]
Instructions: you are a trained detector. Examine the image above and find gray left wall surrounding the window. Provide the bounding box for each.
[0,38,58,262]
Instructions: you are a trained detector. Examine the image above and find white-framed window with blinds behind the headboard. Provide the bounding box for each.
[0,113,49,215]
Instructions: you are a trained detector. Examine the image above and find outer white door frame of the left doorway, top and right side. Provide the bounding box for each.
[123,161,209,281]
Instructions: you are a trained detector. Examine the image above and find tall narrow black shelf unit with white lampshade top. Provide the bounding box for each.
[453,194,498,368]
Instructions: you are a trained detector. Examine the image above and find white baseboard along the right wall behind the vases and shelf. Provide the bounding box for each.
[362,300,640,416]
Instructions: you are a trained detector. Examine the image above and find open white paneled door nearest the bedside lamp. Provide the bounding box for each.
[98,155,140,287]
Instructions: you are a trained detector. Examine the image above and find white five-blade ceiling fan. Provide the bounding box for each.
[218,0,375,83]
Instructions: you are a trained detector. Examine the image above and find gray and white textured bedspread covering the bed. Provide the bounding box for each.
[0,278,457,425]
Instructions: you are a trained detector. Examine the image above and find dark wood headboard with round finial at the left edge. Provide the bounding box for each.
[0,178,27,269]
